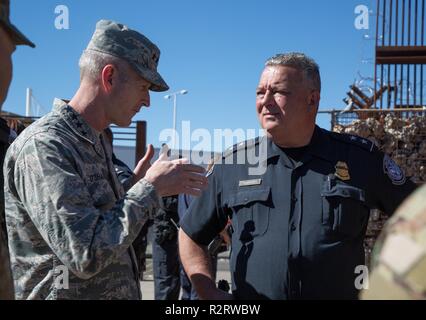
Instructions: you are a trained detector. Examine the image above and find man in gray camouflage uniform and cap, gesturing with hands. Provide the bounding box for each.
[4,20,206,299]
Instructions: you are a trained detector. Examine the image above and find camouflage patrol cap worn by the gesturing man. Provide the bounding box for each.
[86,20,169,91]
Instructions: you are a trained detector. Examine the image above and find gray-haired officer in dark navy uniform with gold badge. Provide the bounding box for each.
[179,53,415,299]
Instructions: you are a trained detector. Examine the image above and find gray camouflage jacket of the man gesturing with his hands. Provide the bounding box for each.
[4,100,159,299]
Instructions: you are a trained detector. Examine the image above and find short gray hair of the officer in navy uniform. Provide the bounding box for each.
[265,52,321,92]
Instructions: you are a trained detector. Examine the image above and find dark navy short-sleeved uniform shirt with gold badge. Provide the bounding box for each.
[181,127,415,299]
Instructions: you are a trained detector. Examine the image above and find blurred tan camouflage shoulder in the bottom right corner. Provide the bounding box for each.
[361,185,426,300]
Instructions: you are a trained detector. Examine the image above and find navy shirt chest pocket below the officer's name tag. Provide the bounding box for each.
[228,187,271,241]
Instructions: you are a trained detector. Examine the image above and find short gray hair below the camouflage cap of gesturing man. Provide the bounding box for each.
[78,50,130,81]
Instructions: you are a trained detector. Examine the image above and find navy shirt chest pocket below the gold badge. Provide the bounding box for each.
[321,180,369,237]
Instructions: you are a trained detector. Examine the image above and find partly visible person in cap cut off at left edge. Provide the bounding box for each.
[0,0,34,299]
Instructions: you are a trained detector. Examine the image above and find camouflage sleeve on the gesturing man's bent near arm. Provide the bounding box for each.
[14,134,158,279]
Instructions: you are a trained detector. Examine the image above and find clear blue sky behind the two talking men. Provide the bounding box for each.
[3,0,375,151]
